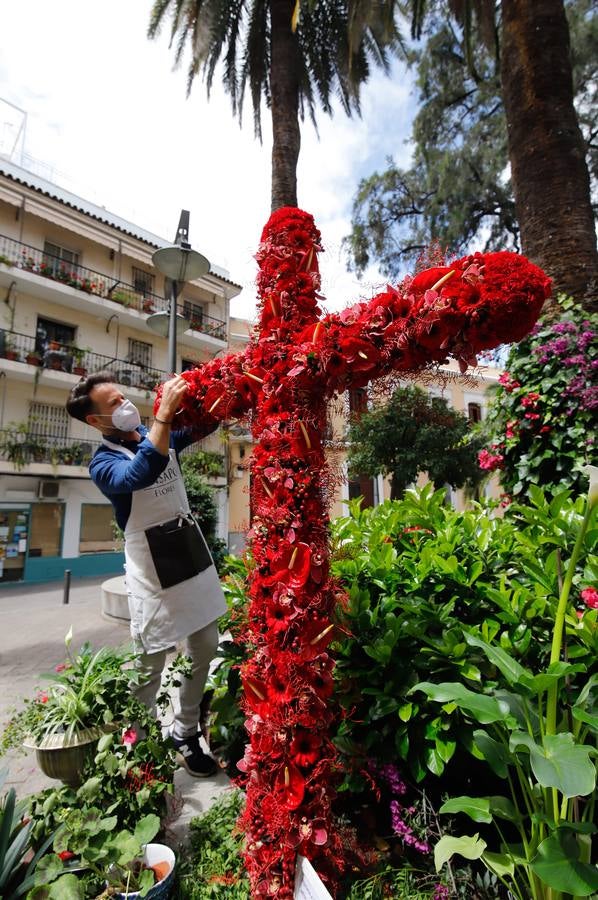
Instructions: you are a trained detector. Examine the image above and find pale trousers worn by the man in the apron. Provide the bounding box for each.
[136,622,218,739]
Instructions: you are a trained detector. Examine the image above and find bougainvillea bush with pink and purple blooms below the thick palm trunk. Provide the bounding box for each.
[479,300,598,497]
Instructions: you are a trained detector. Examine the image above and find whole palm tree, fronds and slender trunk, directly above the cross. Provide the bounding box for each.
[148,0,400,210]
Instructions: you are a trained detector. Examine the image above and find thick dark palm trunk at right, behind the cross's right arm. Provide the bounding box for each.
[501,0,598,307]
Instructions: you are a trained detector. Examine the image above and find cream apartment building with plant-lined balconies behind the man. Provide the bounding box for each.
[0,159,241,585]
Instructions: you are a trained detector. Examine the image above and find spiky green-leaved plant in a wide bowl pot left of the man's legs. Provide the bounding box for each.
[3,632,141,786]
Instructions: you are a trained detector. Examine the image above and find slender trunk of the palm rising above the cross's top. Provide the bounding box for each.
[270,0,301,211]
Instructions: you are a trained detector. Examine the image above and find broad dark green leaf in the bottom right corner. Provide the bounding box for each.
[530,828,598,897]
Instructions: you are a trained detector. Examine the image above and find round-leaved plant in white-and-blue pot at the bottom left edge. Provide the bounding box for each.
[29,807,175,900]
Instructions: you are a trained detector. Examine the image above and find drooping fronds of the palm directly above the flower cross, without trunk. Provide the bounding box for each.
[148,0,402,139]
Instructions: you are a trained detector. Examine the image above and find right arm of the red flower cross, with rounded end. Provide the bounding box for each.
[292,252,550,396]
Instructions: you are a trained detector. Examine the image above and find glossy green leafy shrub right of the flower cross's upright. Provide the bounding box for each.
[332,486,598,790]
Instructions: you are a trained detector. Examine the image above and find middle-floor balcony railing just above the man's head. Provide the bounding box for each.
[0,329,168,390]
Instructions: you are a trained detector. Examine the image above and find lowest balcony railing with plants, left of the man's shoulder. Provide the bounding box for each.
[0,426,101,469]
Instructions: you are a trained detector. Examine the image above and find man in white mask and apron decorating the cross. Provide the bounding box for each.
[66,372,226,777]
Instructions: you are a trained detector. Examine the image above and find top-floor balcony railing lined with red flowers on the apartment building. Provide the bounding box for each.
[0,234,226,341]
